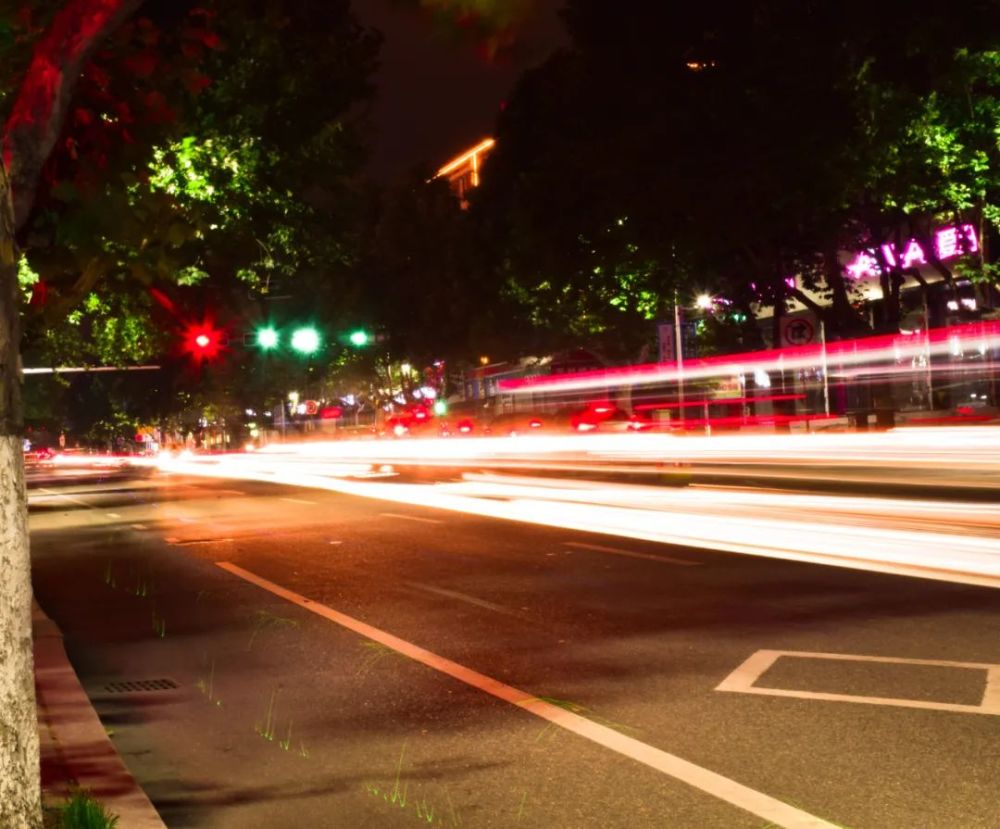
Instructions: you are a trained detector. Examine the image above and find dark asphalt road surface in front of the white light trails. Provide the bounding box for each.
[30,473,1000,829]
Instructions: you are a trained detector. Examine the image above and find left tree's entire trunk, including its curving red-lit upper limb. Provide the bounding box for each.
[0,0,142,829]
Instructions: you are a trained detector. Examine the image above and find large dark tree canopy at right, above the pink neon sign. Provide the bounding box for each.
[472,0,1000,355]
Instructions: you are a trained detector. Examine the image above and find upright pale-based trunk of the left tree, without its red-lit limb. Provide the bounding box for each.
[0,164,42,829]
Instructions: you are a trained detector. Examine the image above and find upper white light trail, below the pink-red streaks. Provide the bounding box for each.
[230,425,1000,490]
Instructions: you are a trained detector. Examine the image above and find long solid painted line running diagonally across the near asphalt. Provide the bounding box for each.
[216,561,837,829]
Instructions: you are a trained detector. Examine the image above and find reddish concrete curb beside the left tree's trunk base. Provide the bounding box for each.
[32,603,166,829]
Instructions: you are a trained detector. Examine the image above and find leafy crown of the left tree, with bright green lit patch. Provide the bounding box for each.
[16,0,379,359]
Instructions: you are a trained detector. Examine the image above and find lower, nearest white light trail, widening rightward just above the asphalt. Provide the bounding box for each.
[146,444,1000,587]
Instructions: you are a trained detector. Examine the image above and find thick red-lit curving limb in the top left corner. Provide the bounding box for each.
[3,0,142,230]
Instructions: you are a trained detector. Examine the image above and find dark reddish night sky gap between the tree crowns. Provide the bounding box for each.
[354,0,566,181]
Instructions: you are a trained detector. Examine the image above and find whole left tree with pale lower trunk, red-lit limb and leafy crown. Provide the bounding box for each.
[0,0,378,829]
